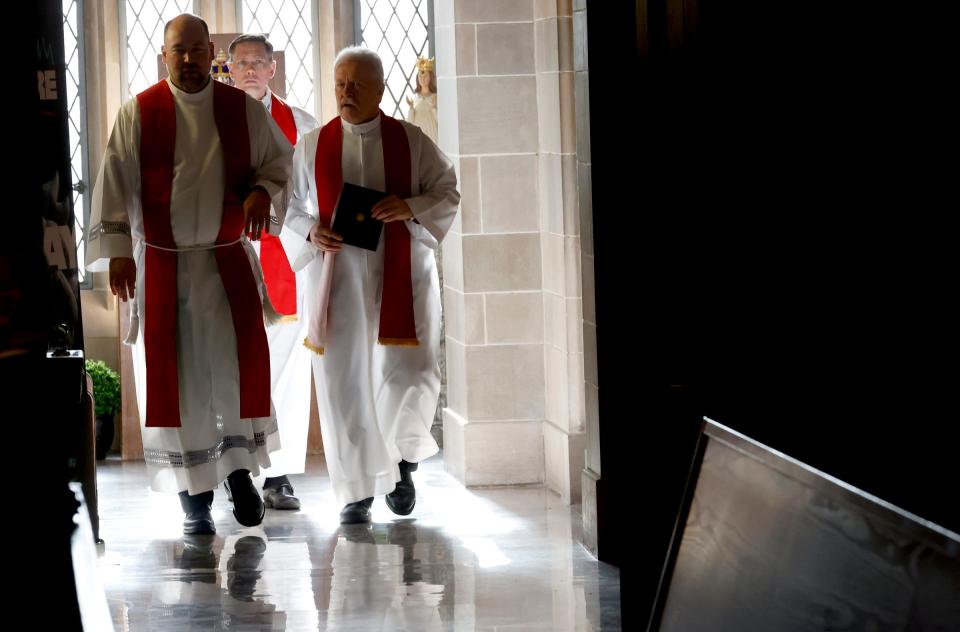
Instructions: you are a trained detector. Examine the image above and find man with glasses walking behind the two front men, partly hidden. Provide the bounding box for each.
[229,33,320,509]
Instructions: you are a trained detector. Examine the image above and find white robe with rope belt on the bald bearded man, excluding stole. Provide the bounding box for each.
[86,80,293,494]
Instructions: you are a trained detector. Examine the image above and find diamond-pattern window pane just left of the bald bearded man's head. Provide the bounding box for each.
[123,0,193,98]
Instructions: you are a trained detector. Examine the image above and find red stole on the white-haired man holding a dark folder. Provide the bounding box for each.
[314,112,419,346]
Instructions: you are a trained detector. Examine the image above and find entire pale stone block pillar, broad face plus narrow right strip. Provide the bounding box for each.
[436,0,592,502]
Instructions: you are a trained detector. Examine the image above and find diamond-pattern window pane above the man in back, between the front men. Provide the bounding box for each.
[241,0,316,113]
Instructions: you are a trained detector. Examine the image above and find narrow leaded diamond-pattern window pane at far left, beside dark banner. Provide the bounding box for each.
[61,0,86,283]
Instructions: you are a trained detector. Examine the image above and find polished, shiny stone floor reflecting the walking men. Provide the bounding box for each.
[97,456,620,632]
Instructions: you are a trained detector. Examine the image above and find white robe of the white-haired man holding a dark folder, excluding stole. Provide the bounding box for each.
[285,116,460,504]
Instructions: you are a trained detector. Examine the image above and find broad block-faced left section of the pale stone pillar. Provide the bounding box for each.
[435,0,546,485]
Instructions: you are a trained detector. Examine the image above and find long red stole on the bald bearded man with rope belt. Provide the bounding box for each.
[137,80,270,428]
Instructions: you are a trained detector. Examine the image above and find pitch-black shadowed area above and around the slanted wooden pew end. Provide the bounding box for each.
[587,0,960,629]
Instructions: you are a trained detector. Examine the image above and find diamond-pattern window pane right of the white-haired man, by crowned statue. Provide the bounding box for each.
[354,0,430,119]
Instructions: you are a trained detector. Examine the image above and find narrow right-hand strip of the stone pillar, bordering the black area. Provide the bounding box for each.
[534,0,585,503]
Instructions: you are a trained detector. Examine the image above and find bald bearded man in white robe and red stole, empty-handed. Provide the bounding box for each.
[86,14,293,534]
